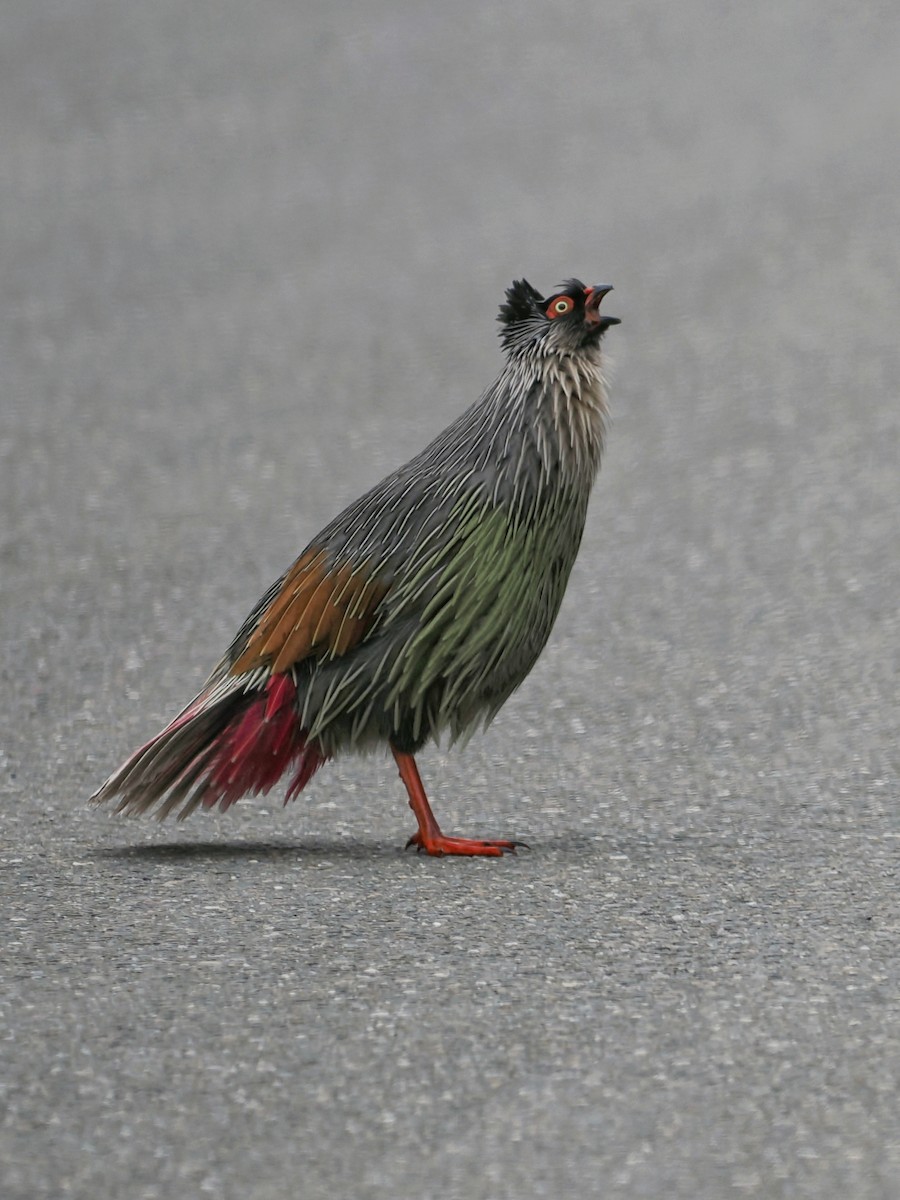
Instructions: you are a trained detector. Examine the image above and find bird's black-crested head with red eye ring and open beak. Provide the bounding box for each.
[497,280,619,354]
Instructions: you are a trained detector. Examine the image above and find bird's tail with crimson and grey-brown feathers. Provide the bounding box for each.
[91,674,326,821]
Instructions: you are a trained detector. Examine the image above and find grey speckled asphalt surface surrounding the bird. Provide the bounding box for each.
[0,0,900,1200]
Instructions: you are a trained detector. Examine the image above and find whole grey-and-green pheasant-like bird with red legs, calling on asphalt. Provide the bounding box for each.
[91,278,620,858]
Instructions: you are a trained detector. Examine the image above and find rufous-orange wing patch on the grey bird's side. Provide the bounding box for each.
[232,546,388,674]
